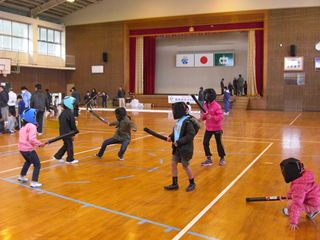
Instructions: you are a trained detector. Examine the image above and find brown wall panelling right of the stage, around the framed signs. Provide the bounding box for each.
[267,7,320,111]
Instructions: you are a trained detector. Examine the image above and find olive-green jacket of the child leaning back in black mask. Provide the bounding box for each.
[109,117,137,141]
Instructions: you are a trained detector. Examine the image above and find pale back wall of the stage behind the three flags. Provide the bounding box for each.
[155,32,248,94]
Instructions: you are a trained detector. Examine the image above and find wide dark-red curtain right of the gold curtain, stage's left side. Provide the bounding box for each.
[143,37,156,94]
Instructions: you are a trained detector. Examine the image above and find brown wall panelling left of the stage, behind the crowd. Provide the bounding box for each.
[66,22,124,98]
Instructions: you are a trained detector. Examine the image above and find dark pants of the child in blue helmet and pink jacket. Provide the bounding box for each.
[20,150,41,182]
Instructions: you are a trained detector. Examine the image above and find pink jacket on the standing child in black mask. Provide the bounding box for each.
[201,101,223,131]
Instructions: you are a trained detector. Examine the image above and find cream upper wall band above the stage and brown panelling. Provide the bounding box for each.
[64,0,320,25]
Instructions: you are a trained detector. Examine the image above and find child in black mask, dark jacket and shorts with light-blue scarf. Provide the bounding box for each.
[164,102,196,192]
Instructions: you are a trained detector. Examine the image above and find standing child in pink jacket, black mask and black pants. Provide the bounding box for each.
[200,88,226,166]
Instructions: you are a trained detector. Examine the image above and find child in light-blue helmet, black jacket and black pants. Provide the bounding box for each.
[53,96,79,164]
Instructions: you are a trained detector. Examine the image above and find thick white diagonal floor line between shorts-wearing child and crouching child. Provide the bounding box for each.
[172,143,273,240]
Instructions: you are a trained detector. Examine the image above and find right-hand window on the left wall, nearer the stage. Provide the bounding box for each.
[38,27,61,57]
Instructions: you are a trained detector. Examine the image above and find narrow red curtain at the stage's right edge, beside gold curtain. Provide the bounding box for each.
[255,30,263,96]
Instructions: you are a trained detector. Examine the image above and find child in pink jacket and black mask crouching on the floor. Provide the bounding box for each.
[280,158,320,230]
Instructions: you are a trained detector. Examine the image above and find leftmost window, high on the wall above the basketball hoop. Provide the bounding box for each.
[0,19,30,52]
